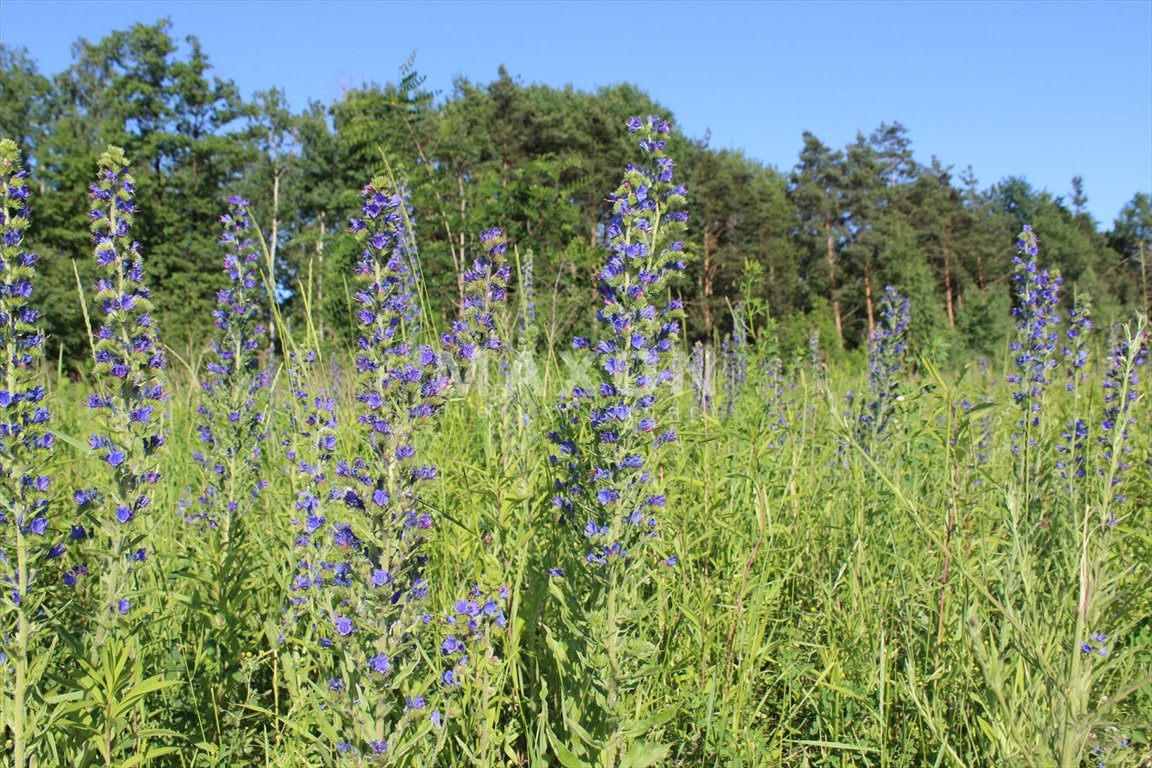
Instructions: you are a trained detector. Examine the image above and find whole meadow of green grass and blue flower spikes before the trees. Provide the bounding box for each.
[0,116,1152,768]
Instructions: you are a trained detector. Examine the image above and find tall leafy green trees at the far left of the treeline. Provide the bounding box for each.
[0,22,257,360]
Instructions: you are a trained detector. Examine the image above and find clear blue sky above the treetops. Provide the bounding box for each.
[0,0,1152,227]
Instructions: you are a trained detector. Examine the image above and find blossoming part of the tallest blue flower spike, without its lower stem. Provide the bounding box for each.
[551,116,687,565]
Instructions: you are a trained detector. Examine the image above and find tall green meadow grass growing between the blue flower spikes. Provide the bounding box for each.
[0,128,1152,768]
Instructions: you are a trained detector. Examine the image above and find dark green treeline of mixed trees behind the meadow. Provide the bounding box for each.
[0,22,1152,364]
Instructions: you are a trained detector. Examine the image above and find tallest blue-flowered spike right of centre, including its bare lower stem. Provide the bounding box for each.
[548,115,688,767]
